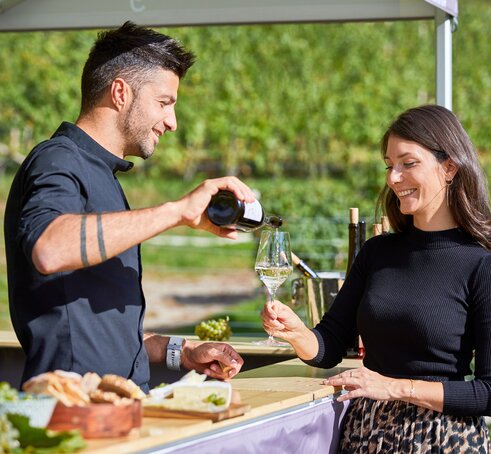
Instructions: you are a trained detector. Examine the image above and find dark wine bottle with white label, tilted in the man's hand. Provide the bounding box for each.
[206,191,283,232]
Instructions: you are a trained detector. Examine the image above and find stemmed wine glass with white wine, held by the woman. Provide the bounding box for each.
[254,229,293,347]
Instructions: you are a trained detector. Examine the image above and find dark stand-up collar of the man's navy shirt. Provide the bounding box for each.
[53,121,133,173]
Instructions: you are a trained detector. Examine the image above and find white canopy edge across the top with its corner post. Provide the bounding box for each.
[0,0,458,109]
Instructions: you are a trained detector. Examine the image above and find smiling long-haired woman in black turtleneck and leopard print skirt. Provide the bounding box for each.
[262,105,491,453]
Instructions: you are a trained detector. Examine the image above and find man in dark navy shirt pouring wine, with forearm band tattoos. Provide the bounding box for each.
[5,22,255,391]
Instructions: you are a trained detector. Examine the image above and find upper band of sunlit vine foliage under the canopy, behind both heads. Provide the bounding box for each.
[0,0,491,183]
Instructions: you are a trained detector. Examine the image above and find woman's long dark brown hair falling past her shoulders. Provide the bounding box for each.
[377,105,491,250]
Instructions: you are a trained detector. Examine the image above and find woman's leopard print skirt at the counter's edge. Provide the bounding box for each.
[338,398,490,454]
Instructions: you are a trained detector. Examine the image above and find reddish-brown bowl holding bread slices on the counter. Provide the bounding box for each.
[48,400,142,438]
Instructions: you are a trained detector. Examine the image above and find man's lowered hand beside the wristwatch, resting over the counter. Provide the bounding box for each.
[181,341,244,380]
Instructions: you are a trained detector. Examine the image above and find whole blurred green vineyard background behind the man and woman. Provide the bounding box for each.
[0,0,491,329]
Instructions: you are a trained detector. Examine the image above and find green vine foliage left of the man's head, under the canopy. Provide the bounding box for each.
[0,32,95,144]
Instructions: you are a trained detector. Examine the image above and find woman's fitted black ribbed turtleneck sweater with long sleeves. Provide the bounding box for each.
[307,228,491,415]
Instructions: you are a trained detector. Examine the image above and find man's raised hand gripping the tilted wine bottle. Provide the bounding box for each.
[175,177,255,239]
